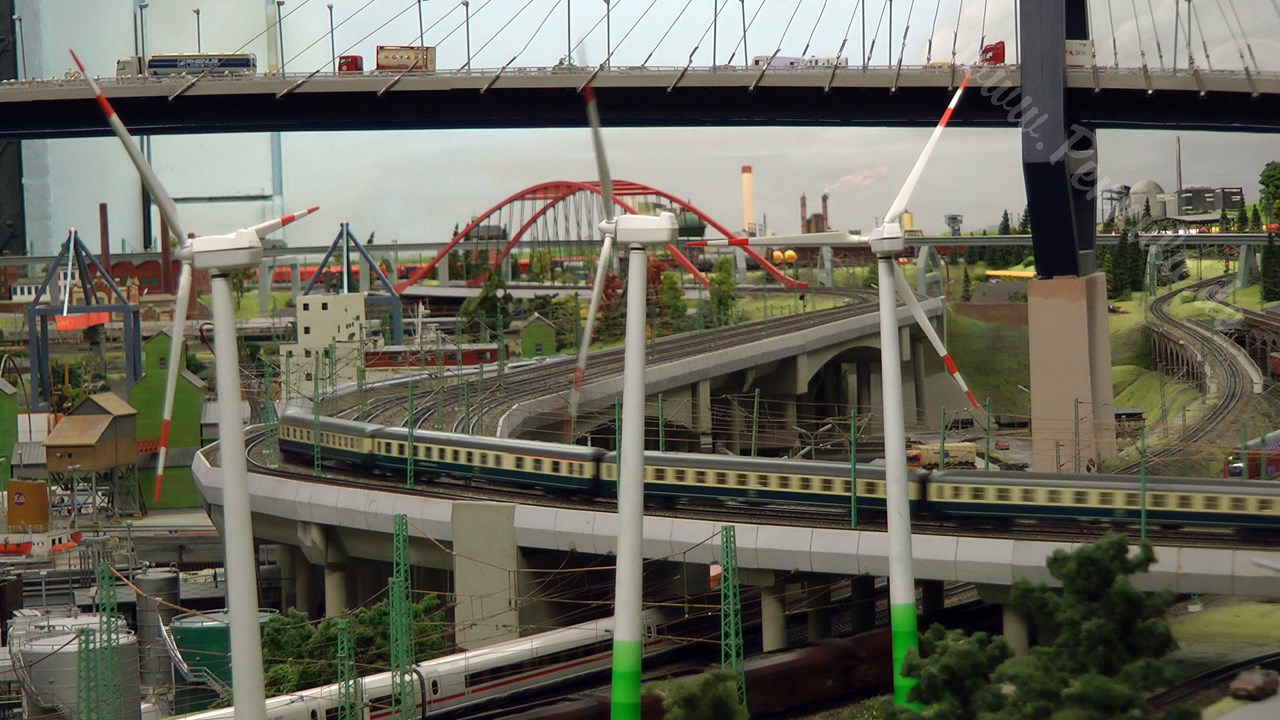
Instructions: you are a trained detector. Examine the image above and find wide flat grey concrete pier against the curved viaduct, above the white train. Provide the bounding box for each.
[453,502,520,650]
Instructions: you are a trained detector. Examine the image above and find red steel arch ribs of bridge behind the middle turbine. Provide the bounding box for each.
[396,181,808,292]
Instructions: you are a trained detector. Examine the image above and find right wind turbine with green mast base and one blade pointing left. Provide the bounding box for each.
[689,70,979,705]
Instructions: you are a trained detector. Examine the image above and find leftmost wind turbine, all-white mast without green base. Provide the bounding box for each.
[72,51,319,720]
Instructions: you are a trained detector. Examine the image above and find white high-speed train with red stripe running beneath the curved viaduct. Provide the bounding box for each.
[183,609,682,720]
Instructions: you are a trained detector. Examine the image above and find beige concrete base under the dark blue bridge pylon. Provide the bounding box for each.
[1027,273,1116,471]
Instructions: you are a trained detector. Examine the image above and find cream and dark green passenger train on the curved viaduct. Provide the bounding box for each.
[279,409,1280,530]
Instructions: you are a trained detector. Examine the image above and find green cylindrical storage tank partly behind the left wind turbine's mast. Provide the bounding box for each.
[169,610,276,714]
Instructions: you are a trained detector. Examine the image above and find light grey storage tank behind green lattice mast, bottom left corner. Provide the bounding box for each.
[17,620,141,720]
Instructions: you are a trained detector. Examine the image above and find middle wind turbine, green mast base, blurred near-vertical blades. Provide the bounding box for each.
[570,83,680,720]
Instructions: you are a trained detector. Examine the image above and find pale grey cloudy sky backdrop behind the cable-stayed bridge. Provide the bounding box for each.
[17,0,1280,252]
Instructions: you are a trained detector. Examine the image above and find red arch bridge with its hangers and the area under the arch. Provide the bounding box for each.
[396,181,806,292]
